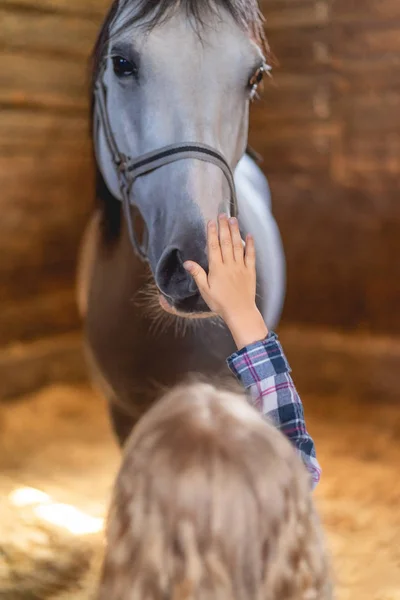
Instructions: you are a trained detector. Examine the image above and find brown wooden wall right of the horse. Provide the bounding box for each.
[251,0,400,333]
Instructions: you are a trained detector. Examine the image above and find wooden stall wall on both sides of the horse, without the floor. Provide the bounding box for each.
[0,0,400,356]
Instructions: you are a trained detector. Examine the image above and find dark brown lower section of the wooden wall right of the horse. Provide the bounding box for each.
[269,173,400,331]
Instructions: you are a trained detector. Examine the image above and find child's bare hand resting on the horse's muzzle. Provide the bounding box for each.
[184,215,268,348]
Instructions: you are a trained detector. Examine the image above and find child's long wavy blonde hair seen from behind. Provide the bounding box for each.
[98,383,331,600]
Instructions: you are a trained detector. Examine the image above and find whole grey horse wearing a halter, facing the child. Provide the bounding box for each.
[78,0,285,445]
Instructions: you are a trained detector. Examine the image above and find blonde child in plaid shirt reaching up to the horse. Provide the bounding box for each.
[98,217,331,600]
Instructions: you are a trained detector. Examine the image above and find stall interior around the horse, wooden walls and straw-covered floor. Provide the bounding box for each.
[0,0,400,600]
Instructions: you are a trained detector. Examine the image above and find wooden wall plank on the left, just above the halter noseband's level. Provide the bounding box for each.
[0,108,90,158]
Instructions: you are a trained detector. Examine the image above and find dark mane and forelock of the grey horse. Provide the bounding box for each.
[90,0,269,241]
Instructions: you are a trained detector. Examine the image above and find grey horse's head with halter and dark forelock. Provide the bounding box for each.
[93,0,266,315]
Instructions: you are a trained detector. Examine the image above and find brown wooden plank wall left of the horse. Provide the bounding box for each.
[0,0,107,347]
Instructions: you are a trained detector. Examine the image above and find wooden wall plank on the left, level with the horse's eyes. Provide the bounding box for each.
[0,50,88,111]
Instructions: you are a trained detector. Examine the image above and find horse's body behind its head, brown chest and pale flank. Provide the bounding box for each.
[78,156,285,443]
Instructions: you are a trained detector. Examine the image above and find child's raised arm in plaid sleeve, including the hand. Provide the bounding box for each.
[184,215,321,487]
